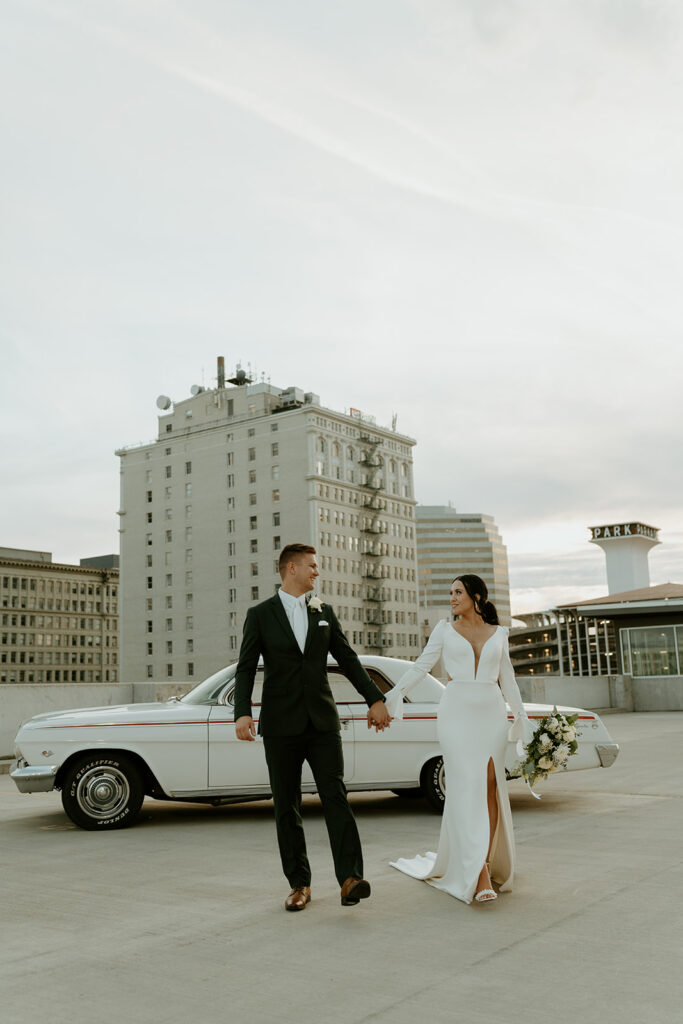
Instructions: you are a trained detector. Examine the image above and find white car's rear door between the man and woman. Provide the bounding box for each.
[353,665,436,787]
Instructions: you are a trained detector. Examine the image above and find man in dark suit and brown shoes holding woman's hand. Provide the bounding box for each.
[234,544,390,910]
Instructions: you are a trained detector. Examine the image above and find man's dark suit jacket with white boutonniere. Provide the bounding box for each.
[234,594,384,736]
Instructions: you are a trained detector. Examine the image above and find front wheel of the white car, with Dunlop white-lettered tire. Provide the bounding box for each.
[61,754,144,831]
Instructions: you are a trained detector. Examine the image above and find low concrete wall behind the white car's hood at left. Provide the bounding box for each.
[0,682,191,758]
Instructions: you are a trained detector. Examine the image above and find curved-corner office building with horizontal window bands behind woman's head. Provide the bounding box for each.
[415,505,510,626]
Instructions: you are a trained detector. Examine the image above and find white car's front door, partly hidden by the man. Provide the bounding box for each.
[209,669,270,796]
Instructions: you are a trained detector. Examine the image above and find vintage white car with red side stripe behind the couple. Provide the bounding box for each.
[10,655,618,830]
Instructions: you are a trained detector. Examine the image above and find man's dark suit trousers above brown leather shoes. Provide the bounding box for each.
[263,724,362,889]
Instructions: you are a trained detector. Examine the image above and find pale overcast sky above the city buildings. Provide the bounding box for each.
[0,0,683,611]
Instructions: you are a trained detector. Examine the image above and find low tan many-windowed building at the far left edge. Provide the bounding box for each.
[0,548,119,683]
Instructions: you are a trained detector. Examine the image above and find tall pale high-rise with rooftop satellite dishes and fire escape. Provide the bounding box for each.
[117,360,419,681]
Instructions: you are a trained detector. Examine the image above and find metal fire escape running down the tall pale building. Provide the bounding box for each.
[358,430,389,653]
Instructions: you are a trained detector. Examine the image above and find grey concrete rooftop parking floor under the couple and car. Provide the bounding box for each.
[0,713,683,1024]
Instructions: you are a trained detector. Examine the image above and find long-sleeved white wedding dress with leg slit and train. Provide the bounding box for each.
[386,618,532,903]
